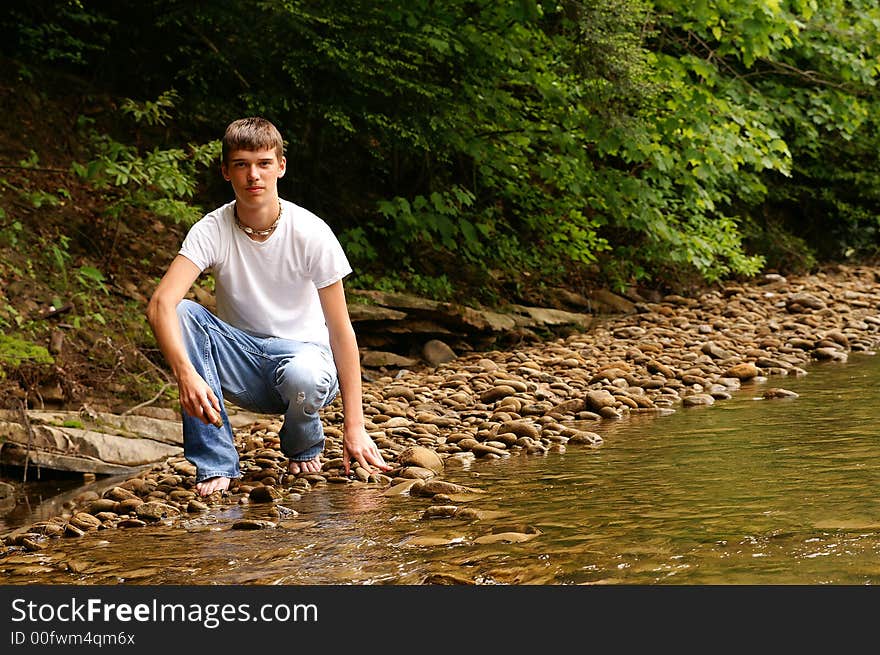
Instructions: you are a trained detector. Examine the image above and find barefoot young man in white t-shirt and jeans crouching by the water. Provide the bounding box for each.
[147,117,390,496]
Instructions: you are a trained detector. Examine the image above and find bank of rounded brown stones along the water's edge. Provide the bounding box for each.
[0,267,880,556]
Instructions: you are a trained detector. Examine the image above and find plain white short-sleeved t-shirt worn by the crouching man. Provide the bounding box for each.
[180,200,351,345]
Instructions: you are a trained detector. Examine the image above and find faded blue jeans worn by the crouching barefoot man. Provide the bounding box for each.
[177,300,339,482]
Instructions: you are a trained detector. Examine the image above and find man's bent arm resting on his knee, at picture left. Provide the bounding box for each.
[147,255,220,423]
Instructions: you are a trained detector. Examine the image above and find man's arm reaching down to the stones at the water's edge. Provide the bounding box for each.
[318,280,391,475]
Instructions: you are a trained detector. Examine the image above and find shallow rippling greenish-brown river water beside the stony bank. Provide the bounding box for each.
[0,354,880,585]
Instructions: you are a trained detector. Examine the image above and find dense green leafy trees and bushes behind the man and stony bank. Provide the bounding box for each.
[0,0,880,297]
